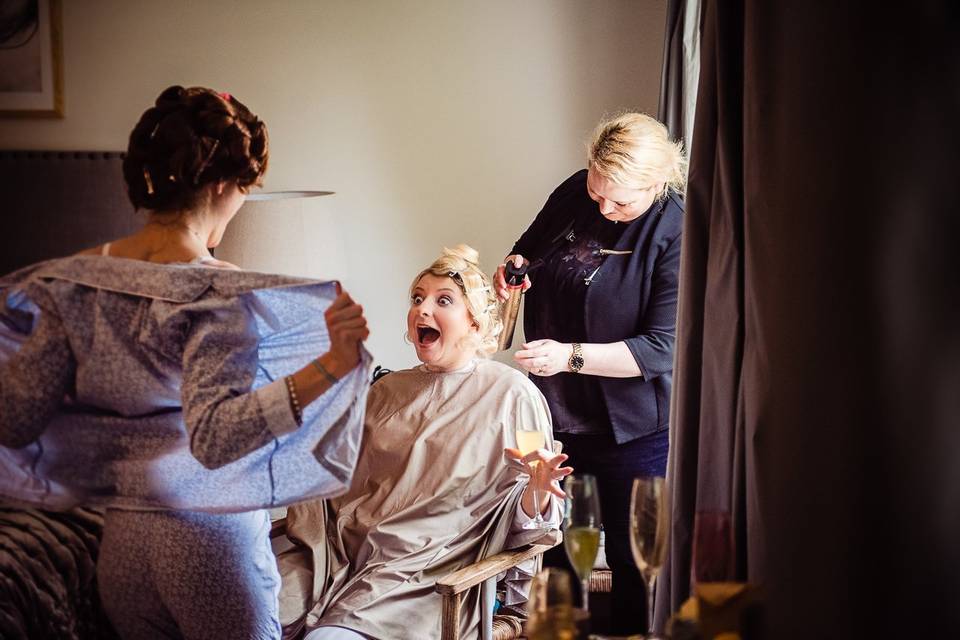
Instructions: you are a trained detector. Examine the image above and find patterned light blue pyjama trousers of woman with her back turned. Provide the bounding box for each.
[97,509,281,640]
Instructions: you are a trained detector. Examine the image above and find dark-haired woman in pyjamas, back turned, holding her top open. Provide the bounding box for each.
[0,86,369,640]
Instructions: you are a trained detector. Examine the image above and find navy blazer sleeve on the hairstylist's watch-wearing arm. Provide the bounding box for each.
[624,235,681,380]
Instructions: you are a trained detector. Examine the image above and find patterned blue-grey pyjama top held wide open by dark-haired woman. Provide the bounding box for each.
[0,256,370,512]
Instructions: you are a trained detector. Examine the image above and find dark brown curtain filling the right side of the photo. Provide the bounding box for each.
[658,0,960,640]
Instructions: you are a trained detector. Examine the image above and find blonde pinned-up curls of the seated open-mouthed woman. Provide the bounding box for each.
[410,244,503,356]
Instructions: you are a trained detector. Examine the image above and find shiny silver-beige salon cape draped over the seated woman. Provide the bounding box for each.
[280,360,552,640]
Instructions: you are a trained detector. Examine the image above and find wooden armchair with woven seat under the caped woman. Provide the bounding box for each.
[270,518,563,640]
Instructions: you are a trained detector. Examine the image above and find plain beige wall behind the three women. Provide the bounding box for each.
[0,0,665,368]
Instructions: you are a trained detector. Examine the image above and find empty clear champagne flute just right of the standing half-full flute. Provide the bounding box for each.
[630,477,669,632]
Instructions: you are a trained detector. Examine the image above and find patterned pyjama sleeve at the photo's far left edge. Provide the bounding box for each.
[0,287,76,449]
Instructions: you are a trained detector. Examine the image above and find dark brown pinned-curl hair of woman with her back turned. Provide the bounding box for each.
[123,86,269,211]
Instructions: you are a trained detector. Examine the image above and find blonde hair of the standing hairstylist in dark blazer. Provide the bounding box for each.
[587,113,687,198]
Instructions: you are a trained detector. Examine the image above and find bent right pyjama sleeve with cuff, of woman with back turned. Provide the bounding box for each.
[182,297,298,469]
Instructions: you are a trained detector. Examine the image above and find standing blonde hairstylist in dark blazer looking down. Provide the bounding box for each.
[495,113,687,635]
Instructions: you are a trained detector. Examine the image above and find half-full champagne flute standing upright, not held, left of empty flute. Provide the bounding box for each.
[563,474,600,611]
